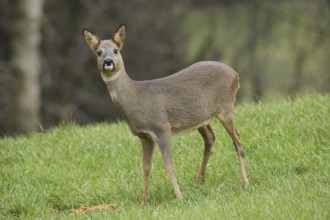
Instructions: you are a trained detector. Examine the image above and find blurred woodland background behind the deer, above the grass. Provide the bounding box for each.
[0,0,330,136]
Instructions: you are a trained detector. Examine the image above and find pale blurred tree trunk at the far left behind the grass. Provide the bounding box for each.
[8,0,43,134]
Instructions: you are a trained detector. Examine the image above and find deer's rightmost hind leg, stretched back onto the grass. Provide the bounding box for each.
[217,111,249,186]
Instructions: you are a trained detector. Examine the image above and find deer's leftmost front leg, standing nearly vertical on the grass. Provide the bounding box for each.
[140,137,155,205]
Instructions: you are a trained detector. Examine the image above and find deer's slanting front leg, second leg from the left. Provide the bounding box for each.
[157,133,182,200]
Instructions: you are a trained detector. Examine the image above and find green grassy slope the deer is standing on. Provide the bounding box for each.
[0,94,330,219]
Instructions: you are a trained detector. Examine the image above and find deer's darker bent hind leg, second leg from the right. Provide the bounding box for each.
[197,124,215,182]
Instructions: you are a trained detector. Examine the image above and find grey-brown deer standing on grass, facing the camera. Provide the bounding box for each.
[83,24,249,204]
